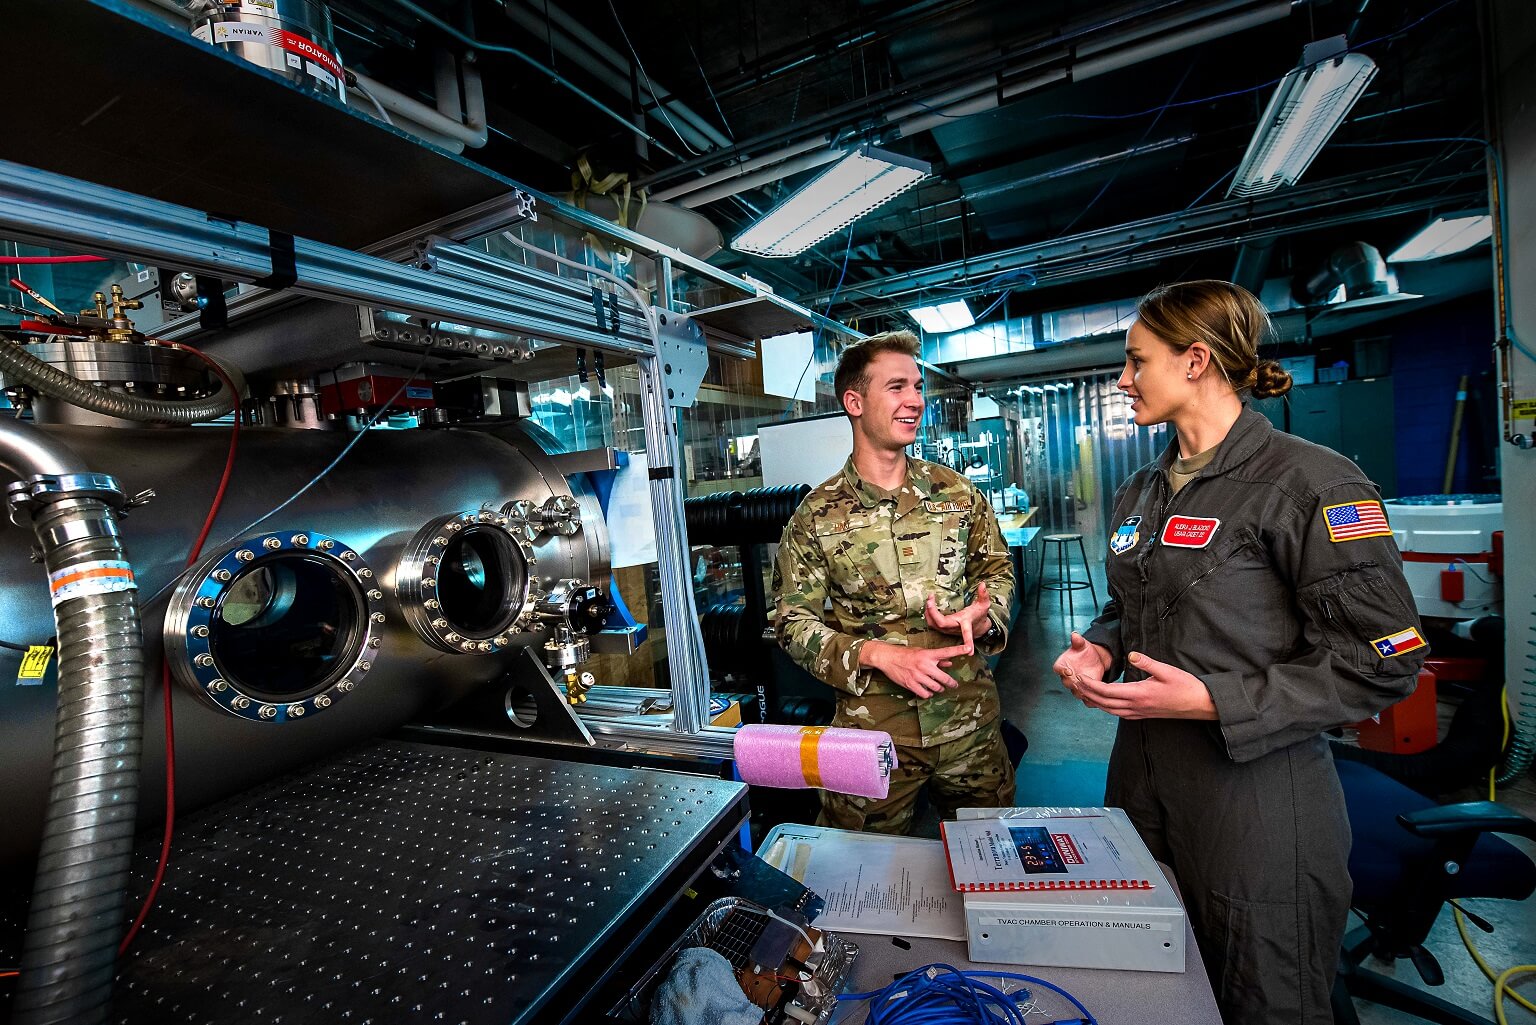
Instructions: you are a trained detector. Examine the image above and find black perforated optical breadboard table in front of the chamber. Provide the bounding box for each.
[114,741,746,1025]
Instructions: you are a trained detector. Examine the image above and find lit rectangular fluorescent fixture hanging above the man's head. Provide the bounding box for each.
[731,146,932,257]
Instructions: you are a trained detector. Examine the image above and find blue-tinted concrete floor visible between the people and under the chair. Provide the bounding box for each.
[997,569,1536,1025]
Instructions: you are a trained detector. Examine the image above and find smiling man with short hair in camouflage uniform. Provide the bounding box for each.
[774,332,1014,833]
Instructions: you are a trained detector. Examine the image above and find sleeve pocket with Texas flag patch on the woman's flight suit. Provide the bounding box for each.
[1298,562,1424,676]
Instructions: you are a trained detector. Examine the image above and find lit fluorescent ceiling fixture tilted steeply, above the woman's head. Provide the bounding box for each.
[1227,35,1376,198]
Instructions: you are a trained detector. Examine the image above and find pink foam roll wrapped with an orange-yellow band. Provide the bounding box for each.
[736,724,895,798]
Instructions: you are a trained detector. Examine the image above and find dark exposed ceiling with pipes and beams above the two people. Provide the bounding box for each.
[141,0,1487,344]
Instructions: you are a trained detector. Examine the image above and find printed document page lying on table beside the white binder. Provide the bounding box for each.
[762,825,965,939]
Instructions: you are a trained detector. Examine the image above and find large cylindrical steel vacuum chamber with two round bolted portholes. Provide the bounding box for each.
[0,426,608,868]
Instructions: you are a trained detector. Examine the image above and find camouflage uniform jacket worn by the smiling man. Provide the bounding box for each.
[773,458,1014,747]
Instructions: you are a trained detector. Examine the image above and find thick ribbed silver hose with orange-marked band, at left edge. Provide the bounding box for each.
[0,421,144,1025]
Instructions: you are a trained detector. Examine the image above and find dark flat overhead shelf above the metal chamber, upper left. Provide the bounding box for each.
[0,0,516,249]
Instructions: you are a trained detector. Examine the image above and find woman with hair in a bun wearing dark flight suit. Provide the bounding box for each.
[1054,281,1428,1025]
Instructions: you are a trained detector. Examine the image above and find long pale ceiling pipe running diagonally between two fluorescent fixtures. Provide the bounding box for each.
[656,0,1292,206]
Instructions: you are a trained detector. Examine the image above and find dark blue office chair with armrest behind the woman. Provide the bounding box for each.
[1333,761,1536,1025]
